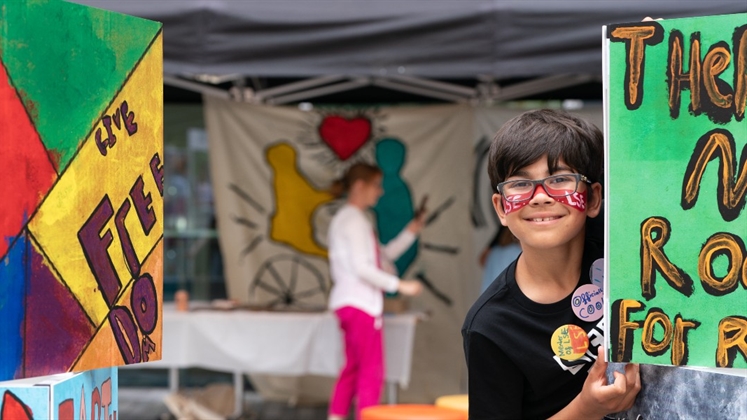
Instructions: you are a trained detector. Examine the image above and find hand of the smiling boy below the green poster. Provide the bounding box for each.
[579,346,641,417]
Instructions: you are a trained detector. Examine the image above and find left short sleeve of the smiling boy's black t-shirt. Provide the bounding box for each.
[464,331,524,420]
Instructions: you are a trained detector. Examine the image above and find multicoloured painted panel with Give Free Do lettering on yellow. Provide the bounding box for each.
[0,0,163,380]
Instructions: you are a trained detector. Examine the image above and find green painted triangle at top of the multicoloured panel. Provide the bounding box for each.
[0,0,161,172]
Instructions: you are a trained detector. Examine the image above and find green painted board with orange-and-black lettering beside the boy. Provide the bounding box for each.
[604,14,747,368]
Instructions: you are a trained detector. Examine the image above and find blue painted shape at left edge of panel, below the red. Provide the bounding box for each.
[0,232,29,381]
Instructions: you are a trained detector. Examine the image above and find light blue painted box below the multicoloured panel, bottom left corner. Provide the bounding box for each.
[0,368,119,420]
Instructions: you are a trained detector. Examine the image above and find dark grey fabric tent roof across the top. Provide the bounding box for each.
[73,0,747,78]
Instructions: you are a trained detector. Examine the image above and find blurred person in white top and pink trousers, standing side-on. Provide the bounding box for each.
[328,163,423,420]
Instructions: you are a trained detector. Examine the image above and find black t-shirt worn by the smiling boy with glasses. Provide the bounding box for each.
[462,240,604,420]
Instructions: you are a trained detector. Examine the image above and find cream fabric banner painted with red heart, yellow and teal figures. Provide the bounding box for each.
[204,97,479,402]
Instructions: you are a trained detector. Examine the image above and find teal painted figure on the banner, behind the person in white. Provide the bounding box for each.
[373,138,418,276]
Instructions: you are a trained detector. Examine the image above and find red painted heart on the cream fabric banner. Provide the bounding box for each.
[319,115,371,160]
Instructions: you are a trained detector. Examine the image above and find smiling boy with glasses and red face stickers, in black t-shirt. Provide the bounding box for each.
[462,110,640,420]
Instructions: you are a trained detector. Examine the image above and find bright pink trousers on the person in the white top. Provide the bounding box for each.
[329,306,384,419]
